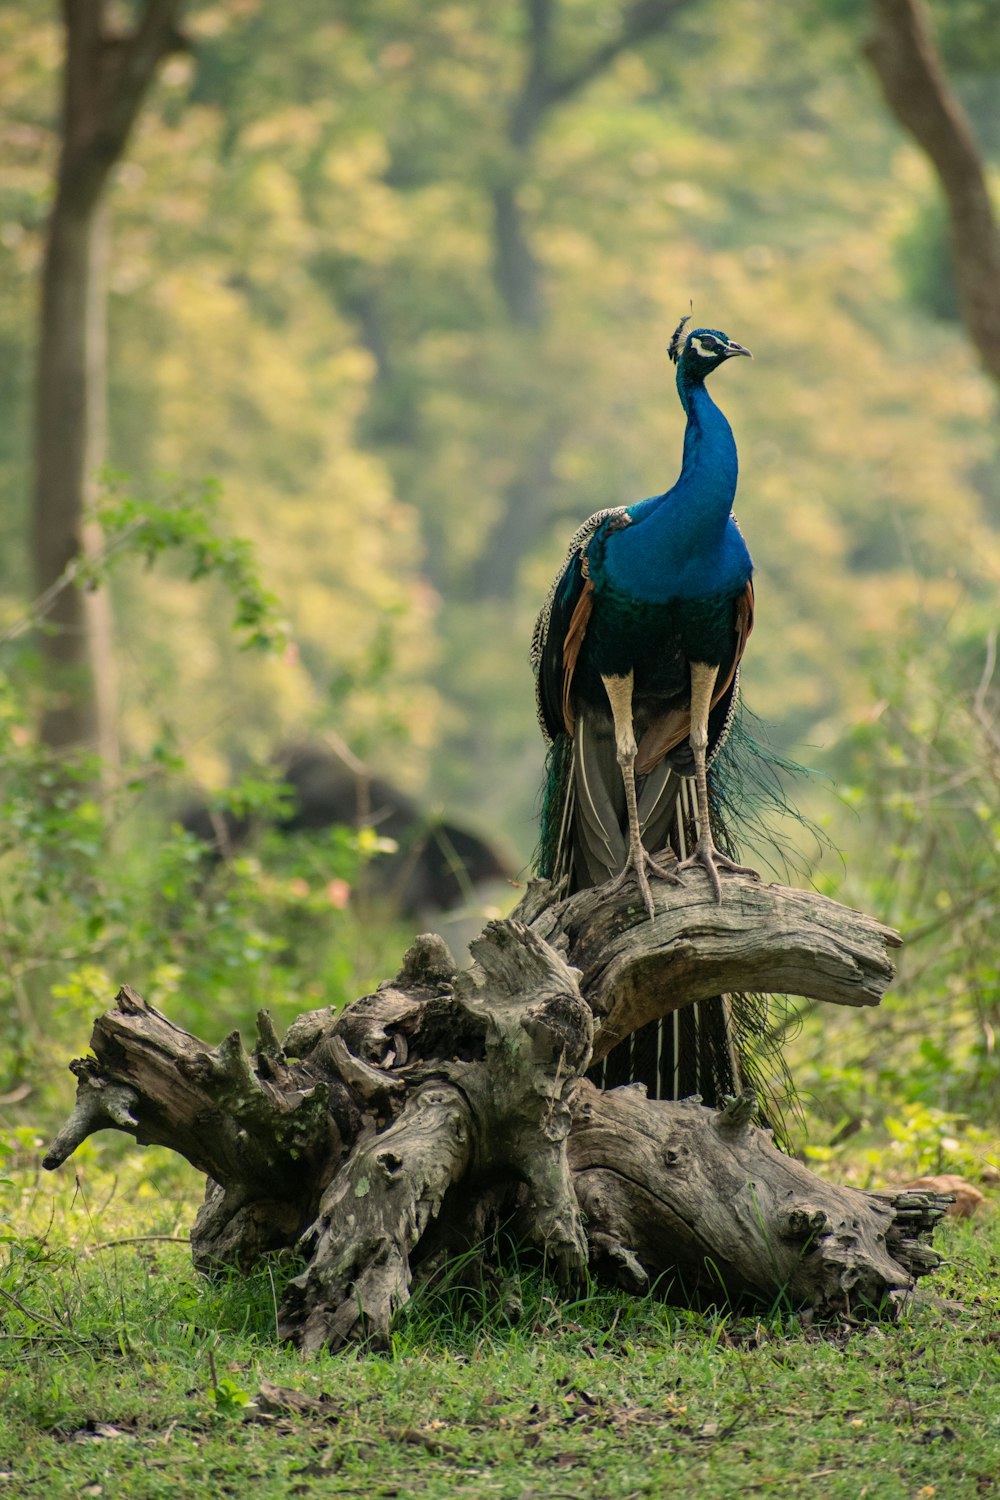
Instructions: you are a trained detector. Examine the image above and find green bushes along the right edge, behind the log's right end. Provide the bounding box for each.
[792,614,1000,1146]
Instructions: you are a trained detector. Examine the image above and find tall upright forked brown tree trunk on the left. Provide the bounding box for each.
[31,0,184,759]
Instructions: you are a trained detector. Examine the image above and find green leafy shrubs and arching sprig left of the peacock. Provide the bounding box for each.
[0,486,402,1119]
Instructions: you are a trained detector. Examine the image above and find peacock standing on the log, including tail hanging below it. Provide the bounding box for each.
[531,318,756,1103]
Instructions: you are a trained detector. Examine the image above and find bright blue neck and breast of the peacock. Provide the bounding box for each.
[593,369,750,600]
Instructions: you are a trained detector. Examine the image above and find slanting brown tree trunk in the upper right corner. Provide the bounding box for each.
[865,0,1000,383]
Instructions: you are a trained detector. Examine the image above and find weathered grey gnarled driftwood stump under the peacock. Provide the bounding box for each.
[45,878,943,1350]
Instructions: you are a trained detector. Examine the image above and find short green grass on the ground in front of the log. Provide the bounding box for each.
[0,1137,1000,1500]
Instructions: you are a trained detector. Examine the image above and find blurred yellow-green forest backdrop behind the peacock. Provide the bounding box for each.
[0,0,1000,1146]
